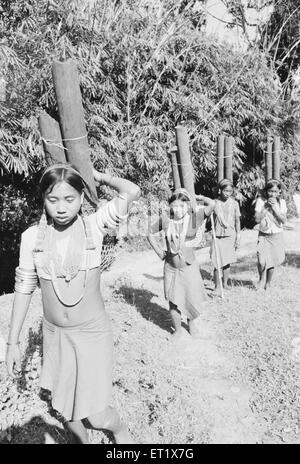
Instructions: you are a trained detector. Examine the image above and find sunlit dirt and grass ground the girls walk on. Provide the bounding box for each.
[0,225,300,444]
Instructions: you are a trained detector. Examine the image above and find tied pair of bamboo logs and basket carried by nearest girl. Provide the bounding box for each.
[39,59,117,271]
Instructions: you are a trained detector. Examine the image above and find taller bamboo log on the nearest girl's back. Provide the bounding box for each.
[52,59,98,205]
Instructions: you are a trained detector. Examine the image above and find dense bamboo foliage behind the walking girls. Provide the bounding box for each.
[0,0,290,197]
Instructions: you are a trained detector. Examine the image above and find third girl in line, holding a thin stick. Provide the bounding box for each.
[211,179,241,292]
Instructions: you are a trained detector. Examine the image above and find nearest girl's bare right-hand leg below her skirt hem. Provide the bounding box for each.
[88,406,134,444]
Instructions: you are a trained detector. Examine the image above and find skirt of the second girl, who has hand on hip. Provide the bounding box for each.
[164,259,208,320]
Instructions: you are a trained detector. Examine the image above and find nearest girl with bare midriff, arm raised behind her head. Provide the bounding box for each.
[6,164,140,443]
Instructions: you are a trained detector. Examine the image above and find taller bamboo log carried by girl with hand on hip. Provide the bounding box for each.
[175,126,196,204]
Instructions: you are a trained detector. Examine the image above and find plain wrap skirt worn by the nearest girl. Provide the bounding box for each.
[40,311,113,421]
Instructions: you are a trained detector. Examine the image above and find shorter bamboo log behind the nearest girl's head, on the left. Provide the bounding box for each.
[39,111,67,166]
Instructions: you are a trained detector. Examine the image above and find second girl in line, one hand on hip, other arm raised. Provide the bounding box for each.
[148,188,214,338]
